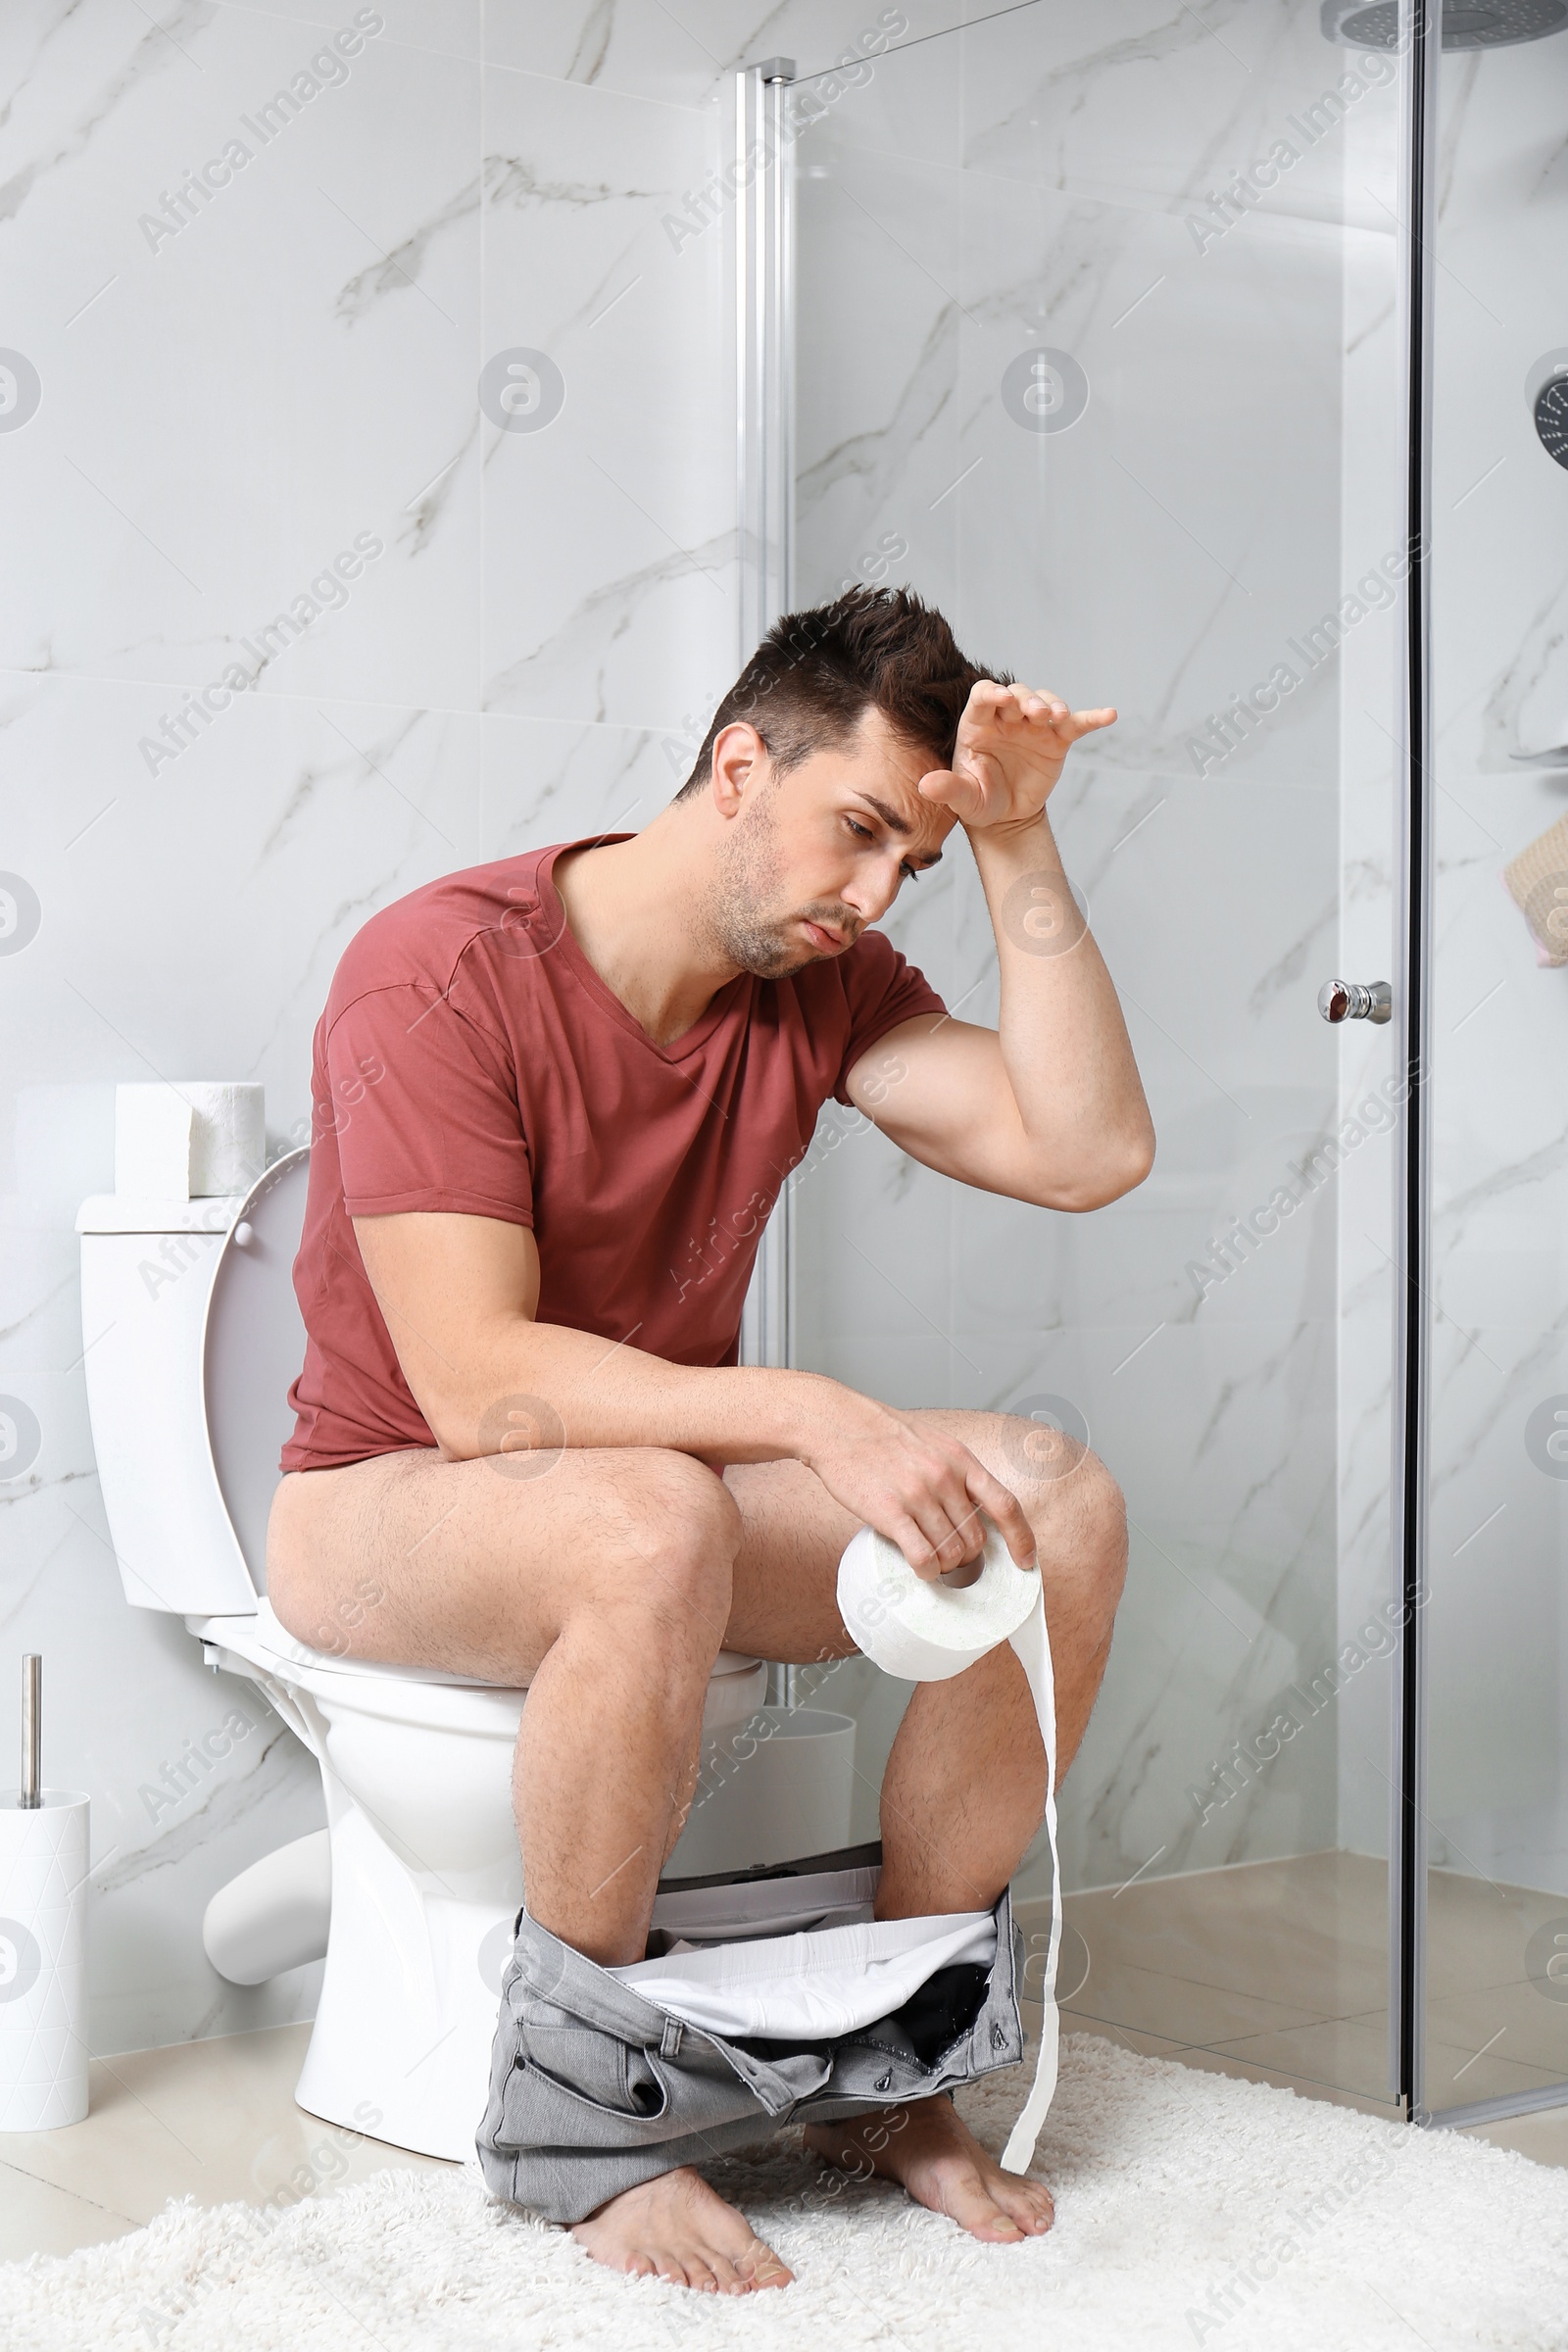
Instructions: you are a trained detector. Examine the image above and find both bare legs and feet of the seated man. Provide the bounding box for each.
[268,1413,1121,2291]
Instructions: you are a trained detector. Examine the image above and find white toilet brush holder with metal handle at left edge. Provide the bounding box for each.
[0,1651,89,2131]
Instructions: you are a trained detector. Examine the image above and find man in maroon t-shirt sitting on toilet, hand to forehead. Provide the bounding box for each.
[268,588,1154,2293]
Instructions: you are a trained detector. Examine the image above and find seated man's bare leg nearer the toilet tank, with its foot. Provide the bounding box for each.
[268,1448,790,2293]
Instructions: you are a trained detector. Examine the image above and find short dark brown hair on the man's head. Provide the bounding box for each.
[674,588,1013,800]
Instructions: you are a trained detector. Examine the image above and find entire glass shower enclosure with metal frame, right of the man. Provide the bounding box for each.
[733,0,1568,2122]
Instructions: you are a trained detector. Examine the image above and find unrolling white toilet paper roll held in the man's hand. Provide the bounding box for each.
[839,1527,1062,2174]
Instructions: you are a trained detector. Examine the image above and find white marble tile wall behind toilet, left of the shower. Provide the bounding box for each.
[0,0,736,2051]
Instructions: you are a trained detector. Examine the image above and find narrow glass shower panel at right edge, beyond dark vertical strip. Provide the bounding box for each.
[1420,10,1568,2117]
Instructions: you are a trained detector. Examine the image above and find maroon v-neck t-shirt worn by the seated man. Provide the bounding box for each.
[282,835,943,1470]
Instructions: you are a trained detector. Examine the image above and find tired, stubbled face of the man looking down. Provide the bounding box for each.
[706,710,955,978]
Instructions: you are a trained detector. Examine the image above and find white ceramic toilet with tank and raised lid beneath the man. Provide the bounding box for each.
[77,1152,799,2162]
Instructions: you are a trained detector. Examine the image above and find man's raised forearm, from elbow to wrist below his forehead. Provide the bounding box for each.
[968,813,1154,1204]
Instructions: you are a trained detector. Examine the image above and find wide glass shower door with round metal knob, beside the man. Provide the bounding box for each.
[785,0,1419,2107]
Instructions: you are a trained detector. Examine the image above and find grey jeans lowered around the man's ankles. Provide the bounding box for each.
[475,1865,1022,2223]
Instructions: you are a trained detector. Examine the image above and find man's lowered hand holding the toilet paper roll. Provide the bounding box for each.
[795,1381,1037,1581]
